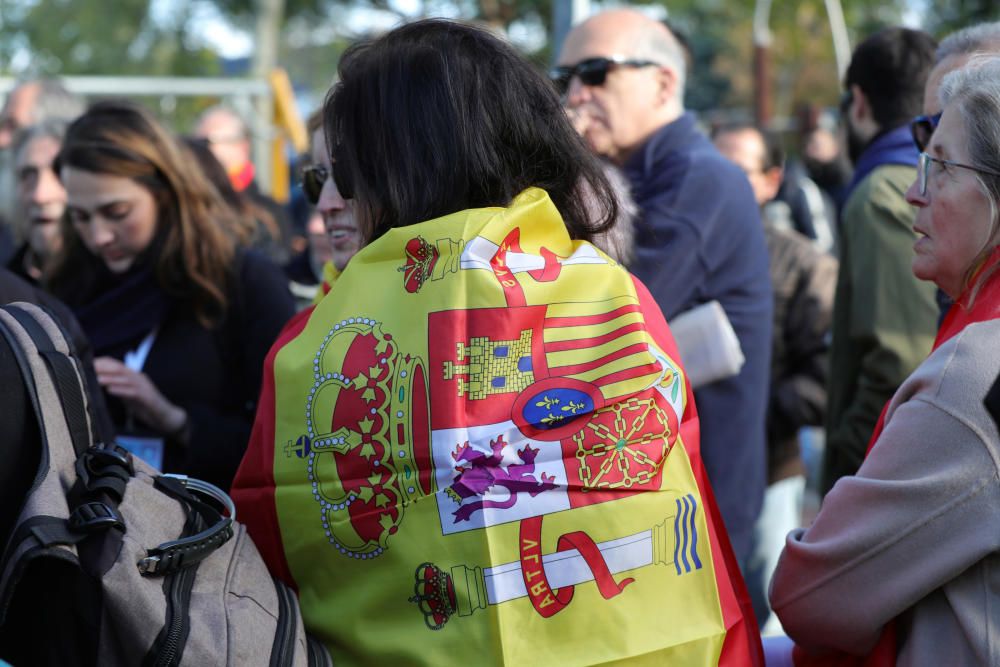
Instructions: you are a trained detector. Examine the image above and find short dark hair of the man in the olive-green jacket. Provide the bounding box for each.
[844,28,937,129]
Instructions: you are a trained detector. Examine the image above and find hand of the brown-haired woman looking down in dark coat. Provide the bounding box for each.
[94,357,187,434]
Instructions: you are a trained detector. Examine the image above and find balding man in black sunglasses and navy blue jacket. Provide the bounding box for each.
[552,9,772,564]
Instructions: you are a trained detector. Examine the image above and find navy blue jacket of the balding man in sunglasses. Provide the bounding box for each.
[625,113,773,563]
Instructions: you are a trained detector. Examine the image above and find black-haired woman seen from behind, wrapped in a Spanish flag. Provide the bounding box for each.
[233,20,761,665]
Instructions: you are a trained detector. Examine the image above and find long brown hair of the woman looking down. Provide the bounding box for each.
[49,100,236,326]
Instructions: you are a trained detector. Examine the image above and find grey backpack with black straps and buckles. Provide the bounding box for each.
[0,303,331,666]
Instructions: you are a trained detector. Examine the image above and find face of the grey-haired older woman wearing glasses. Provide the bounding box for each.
[906,105,996,298]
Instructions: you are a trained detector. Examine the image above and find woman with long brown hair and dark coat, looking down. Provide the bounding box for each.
[49,101,294,488]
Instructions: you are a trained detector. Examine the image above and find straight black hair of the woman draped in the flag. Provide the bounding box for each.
[323,19,618,240]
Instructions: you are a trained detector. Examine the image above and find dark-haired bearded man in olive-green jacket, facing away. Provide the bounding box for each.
[821,28,937,493]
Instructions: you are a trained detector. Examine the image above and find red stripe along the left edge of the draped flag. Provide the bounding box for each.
[230,306,313,590]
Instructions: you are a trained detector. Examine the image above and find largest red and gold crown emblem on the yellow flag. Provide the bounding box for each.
[286,317,433,559]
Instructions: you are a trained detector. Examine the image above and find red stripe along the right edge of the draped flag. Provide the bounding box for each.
[632,276,764,667]
